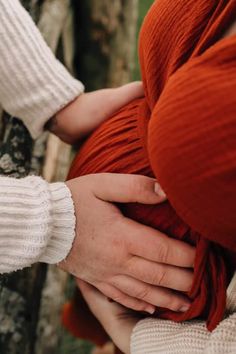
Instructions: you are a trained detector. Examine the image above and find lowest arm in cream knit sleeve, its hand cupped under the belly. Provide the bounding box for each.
[79,278,236,354]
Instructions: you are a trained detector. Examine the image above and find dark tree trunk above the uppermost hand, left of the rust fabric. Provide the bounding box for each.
[73,0,138,90]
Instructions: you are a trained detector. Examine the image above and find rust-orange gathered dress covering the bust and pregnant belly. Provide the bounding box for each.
[63,0,236,344]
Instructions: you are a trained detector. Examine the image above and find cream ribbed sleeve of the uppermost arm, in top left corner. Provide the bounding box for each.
[0,0,84,138]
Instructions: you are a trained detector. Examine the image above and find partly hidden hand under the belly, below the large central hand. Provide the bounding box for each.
[76,279,138,354]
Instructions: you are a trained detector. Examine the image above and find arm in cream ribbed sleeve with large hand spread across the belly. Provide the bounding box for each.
[0,173,195,313]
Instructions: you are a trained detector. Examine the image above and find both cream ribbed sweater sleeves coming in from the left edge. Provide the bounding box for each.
[0,0,83,273]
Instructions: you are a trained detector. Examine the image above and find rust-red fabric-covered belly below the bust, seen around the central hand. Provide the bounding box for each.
[68,99,231,330]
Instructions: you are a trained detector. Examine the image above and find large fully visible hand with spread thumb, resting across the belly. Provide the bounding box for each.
[57,173,195,313]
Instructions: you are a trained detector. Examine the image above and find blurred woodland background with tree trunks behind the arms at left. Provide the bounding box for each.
[0,0,153,354]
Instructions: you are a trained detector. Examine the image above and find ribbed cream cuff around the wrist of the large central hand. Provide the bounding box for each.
[39,183,75,264]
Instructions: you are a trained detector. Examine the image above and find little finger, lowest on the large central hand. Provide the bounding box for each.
[96,283,155,314]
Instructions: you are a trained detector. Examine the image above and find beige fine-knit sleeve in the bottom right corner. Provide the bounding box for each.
[131,275,236,354]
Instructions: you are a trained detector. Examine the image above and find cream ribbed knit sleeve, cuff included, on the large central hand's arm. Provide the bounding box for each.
[0,176,75,273]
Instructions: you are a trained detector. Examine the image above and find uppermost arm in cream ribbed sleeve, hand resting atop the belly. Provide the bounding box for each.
[0,0,143,143]
